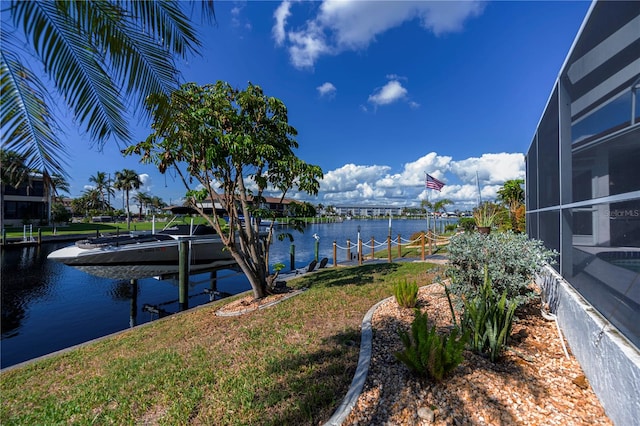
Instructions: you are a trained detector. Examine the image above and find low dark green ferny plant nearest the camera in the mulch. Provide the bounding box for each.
[394,309,468,381]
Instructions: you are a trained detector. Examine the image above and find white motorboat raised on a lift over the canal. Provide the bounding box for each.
[48,225,236,279]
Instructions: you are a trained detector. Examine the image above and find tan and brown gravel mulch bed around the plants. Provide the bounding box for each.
[343,284,613,425]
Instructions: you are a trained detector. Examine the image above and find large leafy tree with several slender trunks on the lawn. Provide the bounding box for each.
[126,82,322,298]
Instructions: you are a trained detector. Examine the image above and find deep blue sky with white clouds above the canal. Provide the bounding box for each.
[58,1,590,210]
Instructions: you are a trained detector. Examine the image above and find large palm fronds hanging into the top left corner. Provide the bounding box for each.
[0,0,215,176]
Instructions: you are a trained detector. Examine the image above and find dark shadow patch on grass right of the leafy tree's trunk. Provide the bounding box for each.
[300,263,400,288]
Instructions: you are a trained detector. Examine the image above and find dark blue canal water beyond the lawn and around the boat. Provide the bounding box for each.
[0,220,450,368]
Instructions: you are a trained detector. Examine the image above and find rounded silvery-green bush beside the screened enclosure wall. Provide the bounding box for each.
[446,232,557,305]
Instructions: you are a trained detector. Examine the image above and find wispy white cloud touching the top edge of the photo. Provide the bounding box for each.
[272,0,484,68]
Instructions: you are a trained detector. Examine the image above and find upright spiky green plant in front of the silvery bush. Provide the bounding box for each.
[462,266,518,362]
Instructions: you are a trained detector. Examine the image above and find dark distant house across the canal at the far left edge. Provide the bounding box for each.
[0,174,49,227]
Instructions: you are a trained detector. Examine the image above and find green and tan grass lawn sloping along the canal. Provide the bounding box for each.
[0,263,436,425]
